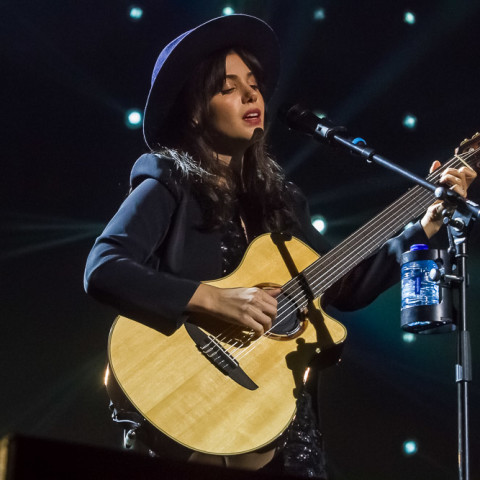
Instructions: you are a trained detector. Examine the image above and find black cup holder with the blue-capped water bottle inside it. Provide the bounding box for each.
[401,244,455,333]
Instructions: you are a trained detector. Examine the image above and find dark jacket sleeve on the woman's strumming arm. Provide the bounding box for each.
[84,178,199,334]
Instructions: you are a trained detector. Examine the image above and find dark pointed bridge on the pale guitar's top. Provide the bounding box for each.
[185,322,258,390]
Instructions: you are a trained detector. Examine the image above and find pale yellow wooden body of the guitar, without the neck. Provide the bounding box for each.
[109,234,346,455]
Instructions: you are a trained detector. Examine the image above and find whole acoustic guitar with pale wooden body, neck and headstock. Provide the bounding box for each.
[108,134,480,455]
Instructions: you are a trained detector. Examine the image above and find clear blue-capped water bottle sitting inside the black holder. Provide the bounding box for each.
[402,244,440,310]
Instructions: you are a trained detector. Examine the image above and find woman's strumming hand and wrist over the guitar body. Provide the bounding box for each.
[187,283,281,336]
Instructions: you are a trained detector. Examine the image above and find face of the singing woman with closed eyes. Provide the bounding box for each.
[209,53,265,154]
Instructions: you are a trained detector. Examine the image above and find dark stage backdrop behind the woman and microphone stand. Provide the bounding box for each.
[0,0,480,480]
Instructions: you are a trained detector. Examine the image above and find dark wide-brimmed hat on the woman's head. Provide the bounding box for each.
[143,14,280,149]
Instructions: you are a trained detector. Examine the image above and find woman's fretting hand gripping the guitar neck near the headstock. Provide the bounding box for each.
[421,160,477,238]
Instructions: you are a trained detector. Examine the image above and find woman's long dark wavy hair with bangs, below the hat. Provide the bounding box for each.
[157,47,295,234]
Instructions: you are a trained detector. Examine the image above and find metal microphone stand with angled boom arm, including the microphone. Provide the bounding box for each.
[279,105,480,480]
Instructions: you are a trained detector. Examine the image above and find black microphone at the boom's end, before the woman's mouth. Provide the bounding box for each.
[277,104,347,143]
